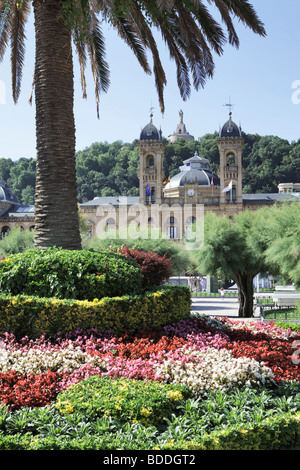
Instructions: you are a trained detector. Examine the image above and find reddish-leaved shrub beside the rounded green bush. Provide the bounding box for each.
[118,245,173,288]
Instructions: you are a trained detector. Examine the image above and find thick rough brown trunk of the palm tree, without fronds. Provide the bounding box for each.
[33,0,81,250]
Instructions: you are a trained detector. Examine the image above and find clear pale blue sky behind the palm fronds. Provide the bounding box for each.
[0,0,300,160]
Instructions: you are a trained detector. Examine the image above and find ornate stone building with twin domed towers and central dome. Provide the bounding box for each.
[0,111,300,239]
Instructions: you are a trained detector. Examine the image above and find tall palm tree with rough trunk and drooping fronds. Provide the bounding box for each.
[0,0,266,249]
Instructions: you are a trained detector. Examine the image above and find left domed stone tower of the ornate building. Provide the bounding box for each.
[137,114,165,204]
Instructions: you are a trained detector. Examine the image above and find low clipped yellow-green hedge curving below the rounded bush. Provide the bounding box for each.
[0,286,191,339]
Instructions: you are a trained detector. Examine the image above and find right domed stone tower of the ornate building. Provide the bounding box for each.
[218,112,244,211]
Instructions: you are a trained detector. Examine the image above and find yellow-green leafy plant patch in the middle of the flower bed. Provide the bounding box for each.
[55,376,191,426]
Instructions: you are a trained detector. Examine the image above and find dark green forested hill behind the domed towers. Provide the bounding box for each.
[0,132,300,204]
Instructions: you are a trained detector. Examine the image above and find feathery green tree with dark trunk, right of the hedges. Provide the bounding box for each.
[195,211,271,318]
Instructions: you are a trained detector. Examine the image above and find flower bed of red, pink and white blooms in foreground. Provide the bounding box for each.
[0,316,300,449]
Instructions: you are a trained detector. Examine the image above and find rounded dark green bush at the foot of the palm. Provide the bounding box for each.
[0,248,142,300]
